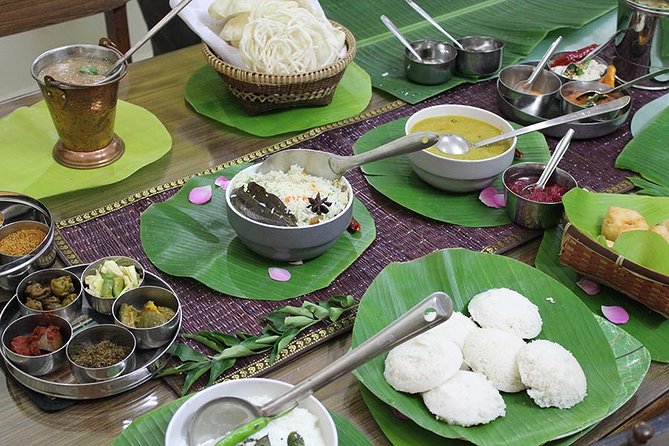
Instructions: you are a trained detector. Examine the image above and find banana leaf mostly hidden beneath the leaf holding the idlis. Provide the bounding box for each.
[360,317,650,446]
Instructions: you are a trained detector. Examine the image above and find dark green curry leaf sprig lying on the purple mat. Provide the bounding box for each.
[156,296,357,395]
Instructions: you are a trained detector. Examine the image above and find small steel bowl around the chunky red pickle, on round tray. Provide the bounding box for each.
[2,313,72,376]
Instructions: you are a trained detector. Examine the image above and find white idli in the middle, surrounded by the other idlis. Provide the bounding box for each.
[462,328,525,392]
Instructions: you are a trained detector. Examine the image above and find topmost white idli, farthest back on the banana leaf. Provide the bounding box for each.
[468,288,543,339]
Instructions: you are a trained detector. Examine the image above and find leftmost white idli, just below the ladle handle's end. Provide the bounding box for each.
[383,337,462,393]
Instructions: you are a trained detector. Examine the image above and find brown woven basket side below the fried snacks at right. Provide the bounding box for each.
[560,223,669,317]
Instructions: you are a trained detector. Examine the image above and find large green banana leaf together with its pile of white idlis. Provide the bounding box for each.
[352,249,621,445]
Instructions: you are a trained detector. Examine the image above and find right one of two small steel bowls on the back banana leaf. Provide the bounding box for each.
[455,36,504,76]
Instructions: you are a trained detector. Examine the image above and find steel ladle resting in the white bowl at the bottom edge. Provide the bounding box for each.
[188,292,453,445]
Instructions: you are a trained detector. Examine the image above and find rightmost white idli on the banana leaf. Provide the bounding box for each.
[518,340,587,409]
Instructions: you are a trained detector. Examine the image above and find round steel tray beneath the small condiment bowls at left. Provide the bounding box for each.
[0,264,183,400]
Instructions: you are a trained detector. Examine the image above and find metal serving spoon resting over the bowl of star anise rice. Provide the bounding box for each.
[258,132,440,180]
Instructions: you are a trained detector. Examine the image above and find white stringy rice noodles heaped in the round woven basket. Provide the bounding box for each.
[239,0,344,75]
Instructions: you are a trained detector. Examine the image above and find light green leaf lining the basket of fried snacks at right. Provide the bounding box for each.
[562,188,669,274]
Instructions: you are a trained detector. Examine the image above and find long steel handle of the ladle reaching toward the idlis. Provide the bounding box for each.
[260,291,453,416]
